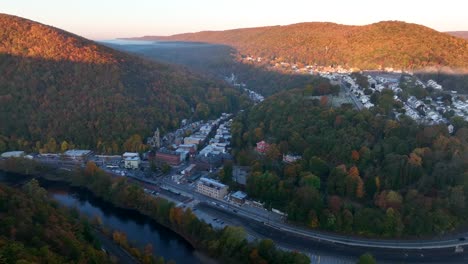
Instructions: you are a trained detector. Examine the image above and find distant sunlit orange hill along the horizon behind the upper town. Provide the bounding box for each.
[131,21,468,70]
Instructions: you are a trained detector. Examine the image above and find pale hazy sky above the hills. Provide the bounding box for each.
[0,0,468,39]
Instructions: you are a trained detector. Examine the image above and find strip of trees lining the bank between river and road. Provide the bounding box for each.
[0,159,310,264]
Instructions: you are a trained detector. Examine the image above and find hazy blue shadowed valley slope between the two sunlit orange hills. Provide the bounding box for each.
[104,42,330,96]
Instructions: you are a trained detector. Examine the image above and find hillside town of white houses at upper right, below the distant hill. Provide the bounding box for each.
[239,56,468,127]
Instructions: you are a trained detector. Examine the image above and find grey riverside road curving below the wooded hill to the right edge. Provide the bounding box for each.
[27,156,468,263]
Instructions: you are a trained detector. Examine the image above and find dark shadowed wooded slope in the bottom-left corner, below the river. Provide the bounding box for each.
[0,180,113,263]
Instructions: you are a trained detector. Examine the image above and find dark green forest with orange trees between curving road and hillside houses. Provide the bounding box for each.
[232,89,468,238]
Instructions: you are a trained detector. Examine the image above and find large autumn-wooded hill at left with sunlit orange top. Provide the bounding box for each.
[0,14,245,153]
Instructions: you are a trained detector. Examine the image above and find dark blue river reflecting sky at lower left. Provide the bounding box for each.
[0,172,213,264]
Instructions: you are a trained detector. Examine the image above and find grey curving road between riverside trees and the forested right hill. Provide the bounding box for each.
[29,157,468,263]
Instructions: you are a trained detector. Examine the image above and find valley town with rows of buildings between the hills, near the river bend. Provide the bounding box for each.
[1,110,288,232]
